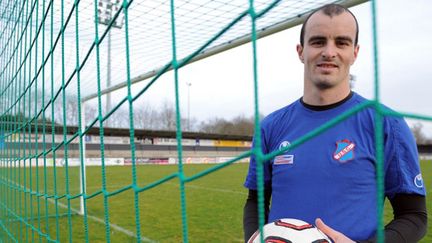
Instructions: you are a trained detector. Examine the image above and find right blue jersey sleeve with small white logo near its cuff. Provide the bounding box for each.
[385,118,426,198]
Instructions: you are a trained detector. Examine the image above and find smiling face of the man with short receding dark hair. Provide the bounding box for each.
[297,12,359,90]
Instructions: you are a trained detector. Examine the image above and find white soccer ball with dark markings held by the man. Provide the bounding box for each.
[248,218,332,243]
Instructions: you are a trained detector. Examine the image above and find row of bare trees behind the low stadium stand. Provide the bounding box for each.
[0,91,432,144]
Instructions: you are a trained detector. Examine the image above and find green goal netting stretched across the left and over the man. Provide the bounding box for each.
[0,0,431,242]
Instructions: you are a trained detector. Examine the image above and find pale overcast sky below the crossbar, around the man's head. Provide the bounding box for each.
[85,0,432,137]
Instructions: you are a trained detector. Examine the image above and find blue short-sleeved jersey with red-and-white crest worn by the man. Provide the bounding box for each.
[245,93,425,240]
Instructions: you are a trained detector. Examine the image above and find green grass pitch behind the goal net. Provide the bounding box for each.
[0,161,432,243]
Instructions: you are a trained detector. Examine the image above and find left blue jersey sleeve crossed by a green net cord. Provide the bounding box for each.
[244,128,271,190]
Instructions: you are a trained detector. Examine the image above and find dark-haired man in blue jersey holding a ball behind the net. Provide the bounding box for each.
[243,4,427,243]
